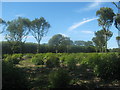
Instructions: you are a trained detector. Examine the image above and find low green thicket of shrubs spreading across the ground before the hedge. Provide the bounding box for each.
[3,53,120,88]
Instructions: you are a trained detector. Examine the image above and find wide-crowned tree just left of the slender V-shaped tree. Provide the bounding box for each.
[5,17,30,53]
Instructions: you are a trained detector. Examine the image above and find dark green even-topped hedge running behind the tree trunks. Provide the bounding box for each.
[0,41,95,54]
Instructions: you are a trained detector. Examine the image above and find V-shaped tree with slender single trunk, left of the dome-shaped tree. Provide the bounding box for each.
[30,17,50,53]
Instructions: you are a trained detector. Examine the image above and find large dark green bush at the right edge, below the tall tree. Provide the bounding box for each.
[94,53,120,80]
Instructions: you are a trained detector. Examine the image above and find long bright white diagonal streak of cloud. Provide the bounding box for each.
[68,18,97,30]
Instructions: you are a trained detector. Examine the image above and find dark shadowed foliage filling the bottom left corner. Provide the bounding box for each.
[2,61,28,90]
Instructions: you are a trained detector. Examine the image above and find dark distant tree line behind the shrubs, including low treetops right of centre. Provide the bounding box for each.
[0,41,96,54]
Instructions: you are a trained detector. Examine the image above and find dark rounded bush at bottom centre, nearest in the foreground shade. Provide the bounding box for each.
[49,69,70,88]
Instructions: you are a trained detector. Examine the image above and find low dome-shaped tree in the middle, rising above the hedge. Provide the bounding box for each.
[48,34,73,53]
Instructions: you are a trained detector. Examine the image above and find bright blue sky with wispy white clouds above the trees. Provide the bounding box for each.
[2,2,118,48]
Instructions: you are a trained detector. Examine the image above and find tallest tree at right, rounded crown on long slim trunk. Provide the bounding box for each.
[96,7,115,52]
